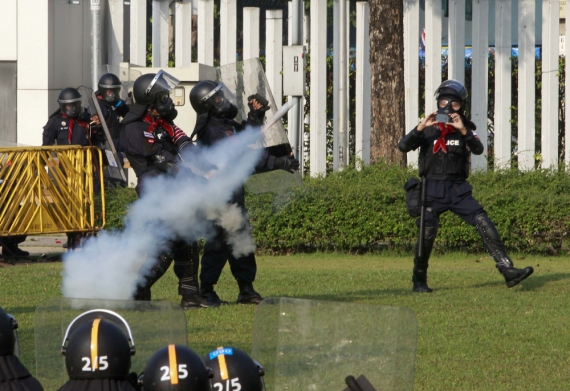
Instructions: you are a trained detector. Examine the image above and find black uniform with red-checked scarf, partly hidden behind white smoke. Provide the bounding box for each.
[120,115,204,300]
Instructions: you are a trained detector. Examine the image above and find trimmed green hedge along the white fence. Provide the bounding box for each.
[100,163,570,254]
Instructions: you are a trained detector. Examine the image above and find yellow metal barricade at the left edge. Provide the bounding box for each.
[0,145,105,236]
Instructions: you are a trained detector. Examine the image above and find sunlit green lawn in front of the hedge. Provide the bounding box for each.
[0,253,570,391]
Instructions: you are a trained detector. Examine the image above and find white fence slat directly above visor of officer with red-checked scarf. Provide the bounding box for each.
[174,0,193,68]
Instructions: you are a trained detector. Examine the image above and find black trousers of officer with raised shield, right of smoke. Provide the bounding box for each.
[200,227,257,286]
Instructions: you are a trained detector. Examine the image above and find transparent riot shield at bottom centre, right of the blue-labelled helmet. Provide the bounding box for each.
[252,298,417,391]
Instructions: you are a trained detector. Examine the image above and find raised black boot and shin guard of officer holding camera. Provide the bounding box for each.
[475,213,534,288]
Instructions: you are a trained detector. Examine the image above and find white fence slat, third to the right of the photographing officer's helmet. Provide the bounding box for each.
[517,0,536,171]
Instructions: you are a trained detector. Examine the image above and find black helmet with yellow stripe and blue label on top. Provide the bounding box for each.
[204,346,265,391]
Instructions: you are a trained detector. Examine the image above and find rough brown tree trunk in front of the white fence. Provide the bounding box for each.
[369,0,406,165]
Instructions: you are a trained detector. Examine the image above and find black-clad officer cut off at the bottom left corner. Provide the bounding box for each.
[0,307,43,391]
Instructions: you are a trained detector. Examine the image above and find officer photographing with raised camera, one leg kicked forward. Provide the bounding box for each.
[398,80,533,292]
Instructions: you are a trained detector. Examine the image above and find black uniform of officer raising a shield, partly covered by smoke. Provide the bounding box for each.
[196,114,275,298]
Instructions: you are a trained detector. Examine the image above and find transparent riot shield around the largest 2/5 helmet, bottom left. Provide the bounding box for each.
[34,298,187,390]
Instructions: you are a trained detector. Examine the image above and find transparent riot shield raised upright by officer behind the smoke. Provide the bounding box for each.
[216,58,303,193]
